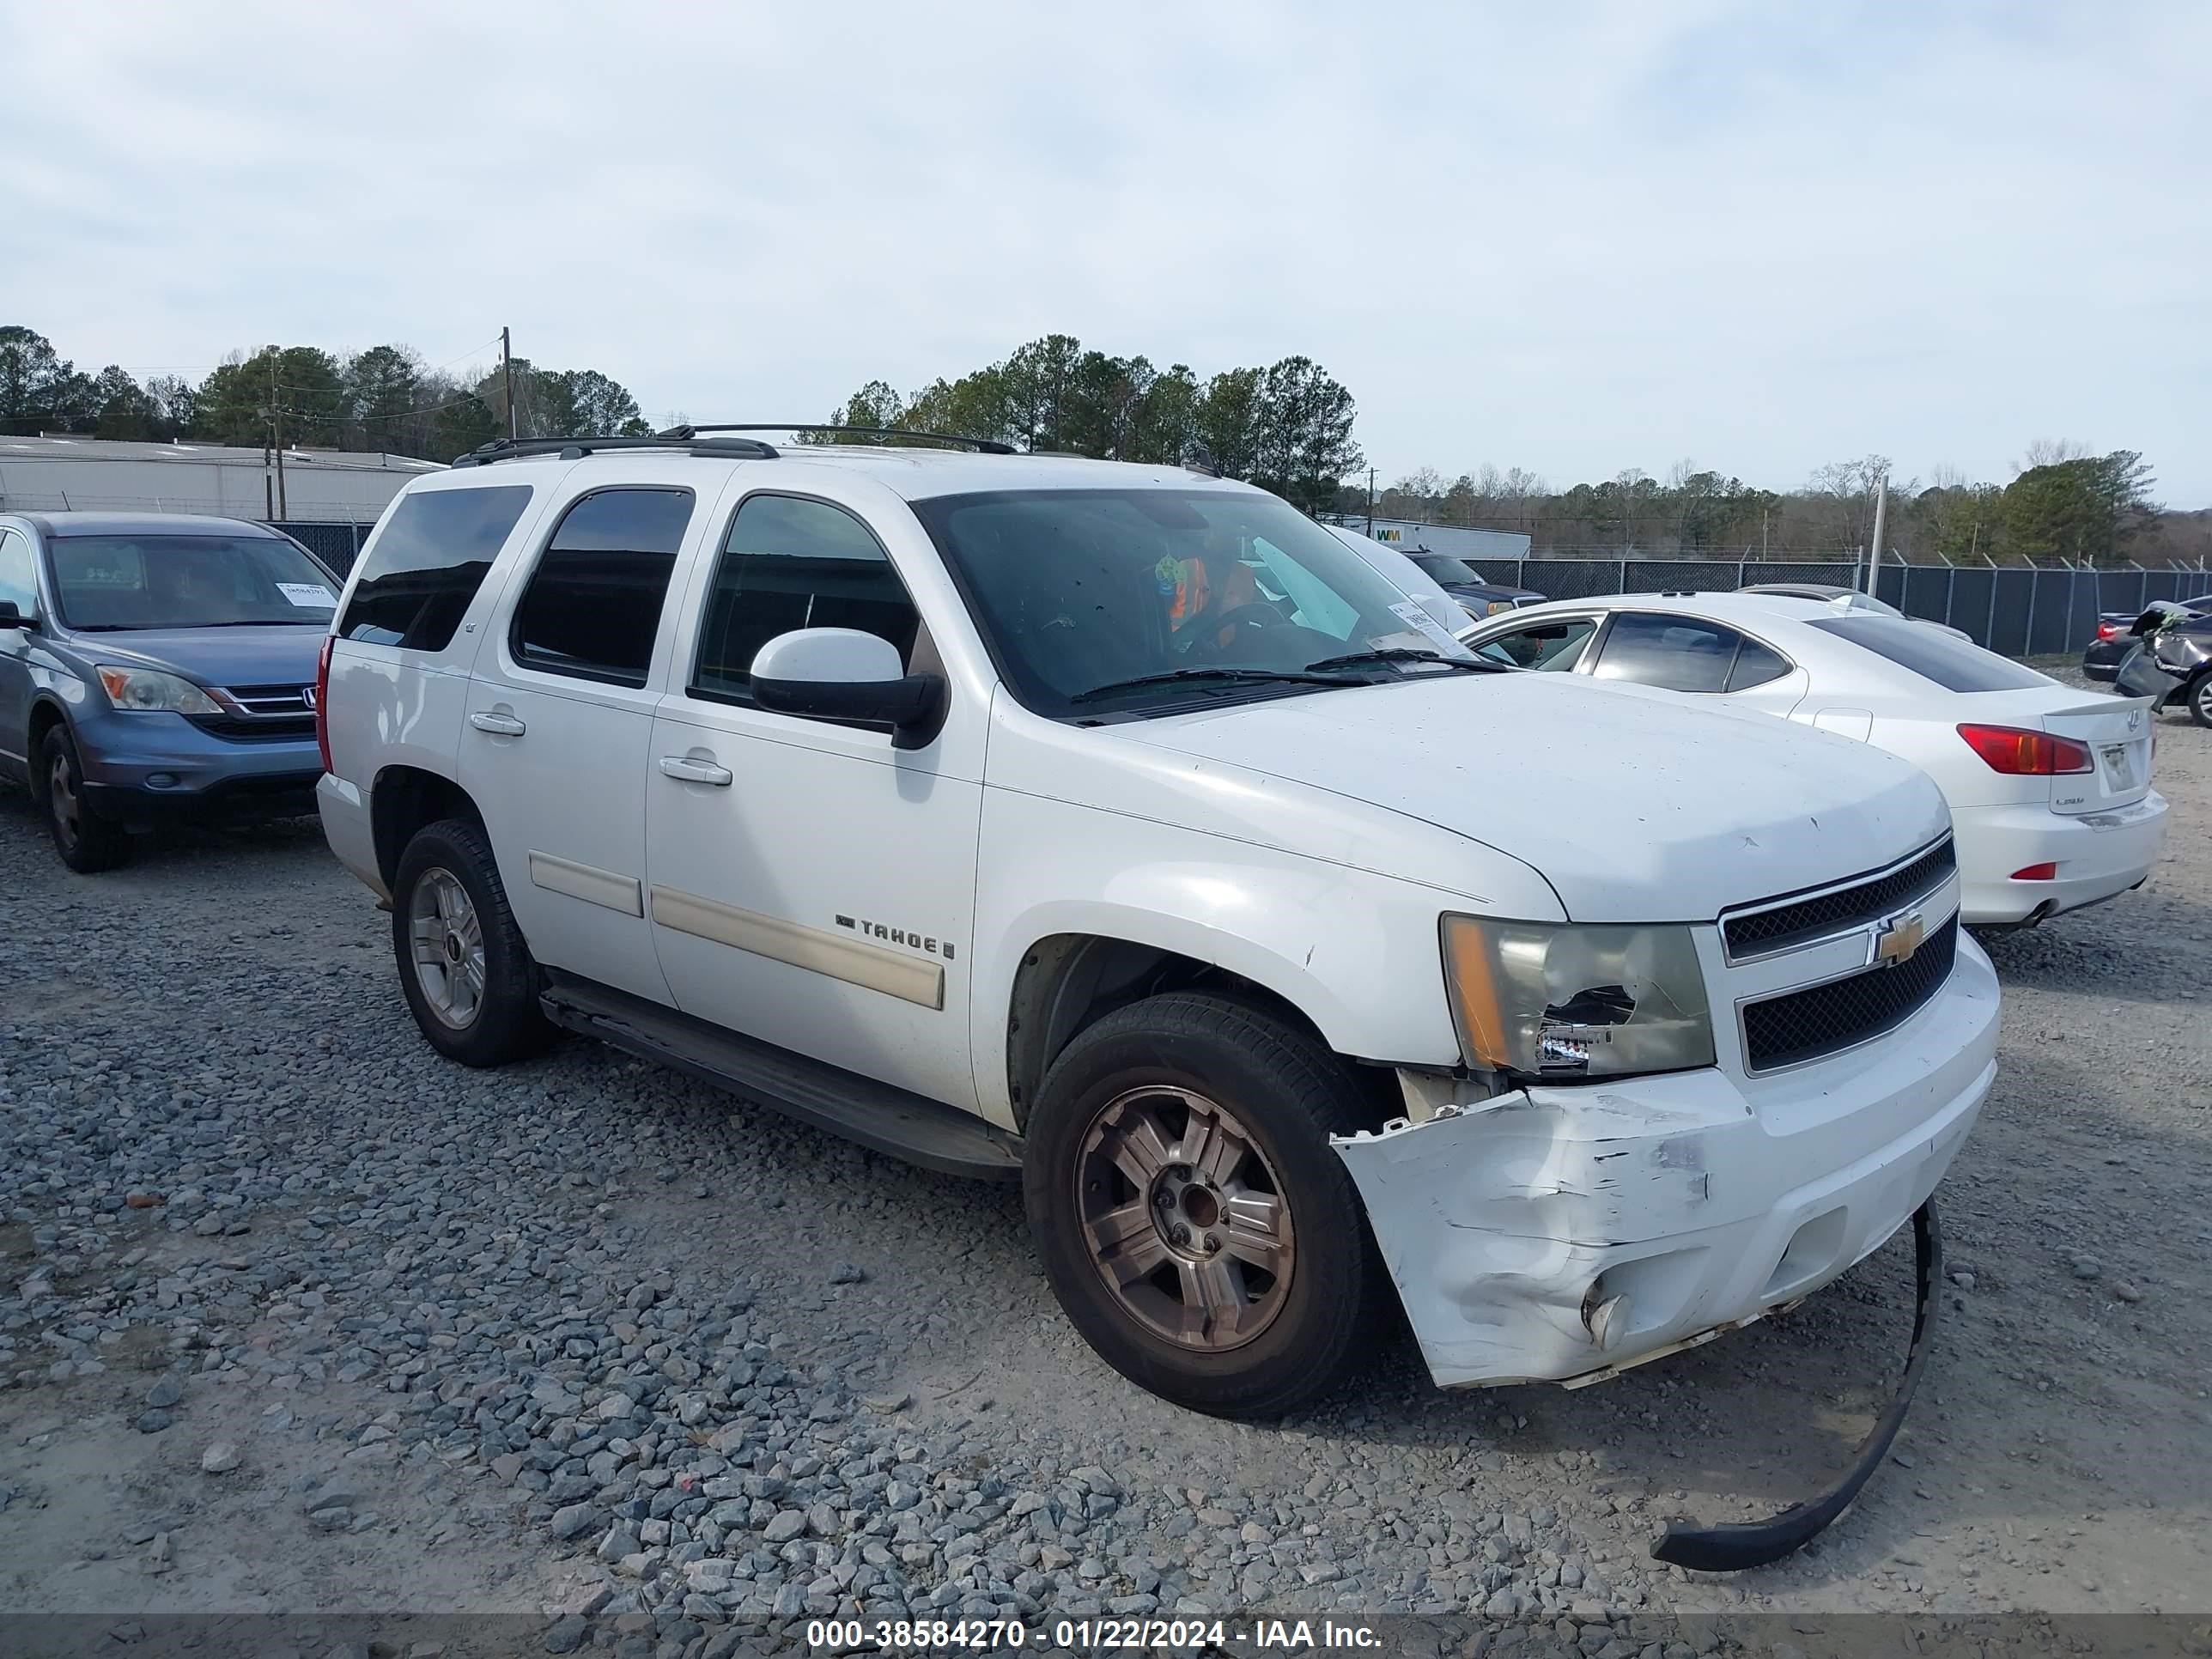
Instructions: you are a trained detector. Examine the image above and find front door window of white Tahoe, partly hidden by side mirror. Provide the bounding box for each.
[690,495,921,703]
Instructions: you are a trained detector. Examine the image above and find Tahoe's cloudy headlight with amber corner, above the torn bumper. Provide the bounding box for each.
[1444,915,1712,1079]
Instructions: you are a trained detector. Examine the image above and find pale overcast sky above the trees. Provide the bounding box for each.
[0,0,2212,507]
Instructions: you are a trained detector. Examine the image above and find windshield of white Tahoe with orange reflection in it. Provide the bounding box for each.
[914,489,1467,717]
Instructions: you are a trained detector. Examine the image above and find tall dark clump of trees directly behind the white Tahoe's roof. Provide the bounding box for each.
[830,334,1367,511]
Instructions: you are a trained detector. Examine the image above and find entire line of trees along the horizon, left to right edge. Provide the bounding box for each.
[13,327,2212,564]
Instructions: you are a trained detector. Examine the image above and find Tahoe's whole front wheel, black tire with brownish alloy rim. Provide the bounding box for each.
[1022,994,1387,1418]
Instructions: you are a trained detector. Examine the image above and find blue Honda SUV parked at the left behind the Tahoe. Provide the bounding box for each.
[0,514,341,874]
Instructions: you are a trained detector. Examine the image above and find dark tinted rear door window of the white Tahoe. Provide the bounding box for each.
[508,489,695,686]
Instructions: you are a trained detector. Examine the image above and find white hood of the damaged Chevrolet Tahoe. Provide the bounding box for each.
[1115,672,1951,938]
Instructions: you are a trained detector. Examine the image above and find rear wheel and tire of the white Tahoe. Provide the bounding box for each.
[392,818,553,1066]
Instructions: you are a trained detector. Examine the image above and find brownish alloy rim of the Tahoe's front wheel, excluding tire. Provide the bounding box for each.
[1075,1086,1297,1352]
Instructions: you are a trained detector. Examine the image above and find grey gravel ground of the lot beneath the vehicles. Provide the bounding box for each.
[0,677,2212,1655]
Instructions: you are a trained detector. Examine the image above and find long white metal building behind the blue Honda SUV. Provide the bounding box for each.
[0,435,441,525]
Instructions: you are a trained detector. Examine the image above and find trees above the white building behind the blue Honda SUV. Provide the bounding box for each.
[0,325,653,460]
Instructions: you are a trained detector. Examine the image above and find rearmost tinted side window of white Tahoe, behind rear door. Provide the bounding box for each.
[338,484,531,650]
